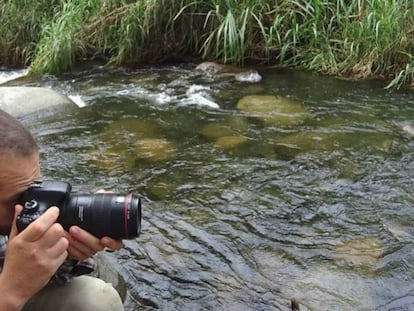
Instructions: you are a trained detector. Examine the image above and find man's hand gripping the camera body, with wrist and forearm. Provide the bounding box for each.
[0,205,69,310]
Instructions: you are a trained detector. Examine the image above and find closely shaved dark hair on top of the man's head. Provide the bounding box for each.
[0,109,38,157]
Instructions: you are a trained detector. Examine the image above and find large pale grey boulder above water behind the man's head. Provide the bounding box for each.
[0,86,76,117]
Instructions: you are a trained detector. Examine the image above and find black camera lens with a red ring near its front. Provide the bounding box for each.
[58,193,141,239]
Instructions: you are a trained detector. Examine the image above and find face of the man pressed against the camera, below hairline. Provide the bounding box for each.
[0,152,40,235]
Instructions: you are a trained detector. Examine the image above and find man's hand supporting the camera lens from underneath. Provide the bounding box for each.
[66,226,122,260]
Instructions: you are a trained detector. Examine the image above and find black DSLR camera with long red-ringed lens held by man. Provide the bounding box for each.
[16,180,141,239]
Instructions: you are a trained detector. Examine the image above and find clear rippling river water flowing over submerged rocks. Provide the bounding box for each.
[2,66,414,311]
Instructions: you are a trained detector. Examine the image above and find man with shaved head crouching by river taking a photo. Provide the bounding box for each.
[0,110,123,311]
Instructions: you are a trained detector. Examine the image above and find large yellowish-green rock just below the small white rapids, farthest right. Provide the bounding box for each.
[237,95,309,126]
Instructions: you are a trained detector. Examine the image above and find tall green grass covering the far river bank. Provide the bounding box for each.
[0,0,414,87]
